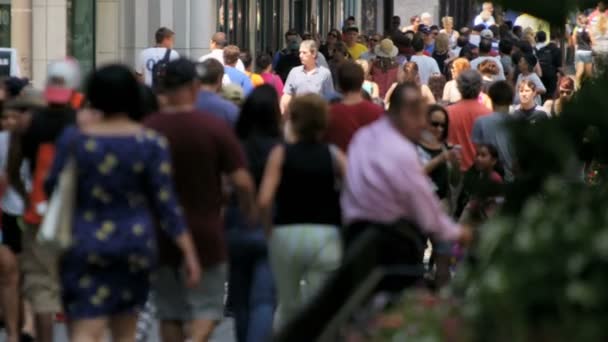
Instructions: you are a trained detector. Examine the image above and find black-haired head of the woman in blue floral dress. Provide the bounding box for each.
[85,64,142,121]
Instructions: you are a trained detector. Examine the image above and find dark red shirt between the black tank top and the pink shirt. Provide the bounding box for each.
[325,101,384,152]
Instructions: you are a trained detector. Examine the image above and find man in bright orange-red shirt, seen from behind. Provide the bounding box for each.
[448,70,491,172]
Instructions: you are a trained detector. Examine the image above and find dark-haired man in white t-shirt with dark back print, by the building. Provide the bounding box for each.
[136,27,179,86]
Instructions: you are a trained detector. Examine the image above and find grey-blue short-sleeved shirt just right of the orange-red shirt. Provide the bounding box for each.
[473,113,514,182]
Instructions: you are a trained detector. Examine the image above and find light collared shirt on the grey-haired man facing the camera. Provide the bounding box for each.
[283,65,334,97]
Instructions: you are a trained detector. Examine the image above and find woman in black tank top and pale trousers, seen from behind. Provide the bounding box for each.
[258,94,346,325]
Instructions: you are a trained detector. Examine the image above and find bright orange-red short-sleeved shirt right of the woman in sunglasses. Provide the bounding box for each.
[448,99,491,172]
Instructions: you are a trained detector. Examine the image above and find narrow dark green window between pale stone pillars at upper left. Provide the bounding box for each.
[67,0,95,74]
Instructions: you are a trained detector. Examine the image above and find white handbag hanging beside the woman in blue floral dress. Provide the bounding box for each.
[37,156,77,252]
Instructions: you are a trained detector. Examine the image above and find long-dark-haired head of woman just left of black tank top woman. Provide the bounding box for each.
[235,84,281,140]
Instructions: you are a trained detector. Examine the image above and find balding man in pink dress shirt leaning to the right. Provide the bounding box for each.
[341,83,471,247]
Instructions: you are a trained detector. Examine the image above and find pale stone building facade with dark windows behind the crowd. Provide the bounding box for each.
[8,0,476,85]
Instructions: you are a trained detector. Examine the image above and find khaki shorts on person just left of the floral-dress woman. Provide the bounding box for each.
[19,224,61,313]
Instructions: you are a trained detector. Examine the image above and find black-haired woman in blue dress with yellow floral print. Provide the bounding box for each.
[47,65,200,341]
